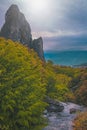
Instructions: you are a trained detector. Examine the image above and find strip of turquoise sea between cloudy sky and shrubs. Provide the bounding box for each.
[44,51,87,66]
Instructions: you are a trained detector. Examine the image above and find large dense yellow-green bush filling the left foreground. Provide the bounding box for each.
[0,38,46,130]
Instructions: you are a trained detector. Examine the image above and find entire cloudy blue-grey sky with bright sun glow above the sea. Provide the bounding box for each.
[0,0,87,50]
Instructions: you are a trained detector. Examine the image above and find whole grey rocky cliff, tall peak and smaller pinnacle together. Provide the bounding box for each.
[0,5,44,60]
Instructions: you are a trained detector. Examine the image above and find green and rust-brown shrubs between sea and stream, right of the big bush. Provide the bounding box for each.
[47,62,87,106]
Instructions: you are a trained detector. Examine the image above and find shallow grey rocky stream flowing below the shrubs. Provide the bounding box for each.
[43,103,85,130]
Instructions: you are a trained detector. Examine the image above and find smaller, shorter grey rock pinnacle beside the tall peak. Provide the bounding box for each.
[32,37,44,60]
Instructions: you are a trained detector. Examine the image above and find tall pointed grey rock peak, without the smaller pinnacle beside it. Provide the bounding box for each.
[0,5,32,46]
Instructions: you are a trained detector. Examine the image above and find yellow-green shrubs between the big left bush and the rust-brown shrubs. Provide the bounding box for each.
[45,61,74,101]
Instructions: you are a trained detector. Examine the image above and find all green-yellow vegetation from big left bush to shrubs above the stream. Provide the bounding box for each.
[0,38,87,130]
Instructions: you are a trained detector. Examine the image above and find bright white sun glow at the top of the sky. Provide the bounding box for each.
[21,0,52,24]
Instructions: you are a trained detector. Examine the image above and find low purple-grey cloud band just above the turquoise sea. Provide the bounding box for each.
[44,33,87,50]
